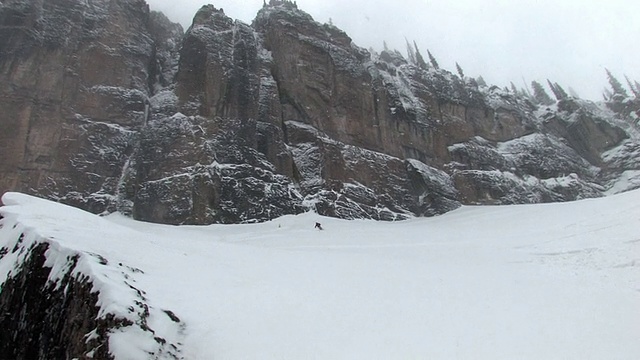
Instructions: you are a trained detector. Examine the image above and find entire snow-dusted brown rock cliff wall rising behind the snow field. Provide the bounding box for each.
[0,0,640,224]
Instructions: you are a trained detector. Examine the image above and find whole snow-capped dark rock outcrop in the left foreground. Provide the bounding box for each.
[0,193,185,359]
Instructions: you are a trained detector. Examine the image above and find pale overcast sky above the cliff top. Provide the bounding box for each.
[147,0,640,100]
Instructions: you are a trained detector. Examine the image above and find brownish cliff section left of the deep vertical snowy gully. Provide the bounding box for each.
[0,0,181,212]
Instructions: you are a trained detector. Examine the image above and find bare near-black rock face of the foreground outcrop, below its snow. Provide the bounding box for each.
[0,244,114,360]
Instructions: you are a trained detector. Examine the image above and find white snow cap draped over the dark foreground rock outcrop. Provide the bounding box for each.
[0,193,185,360]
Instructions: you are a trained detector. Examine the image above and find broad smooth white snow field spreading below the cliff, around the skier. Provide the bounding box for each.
[0,190,640,359]
